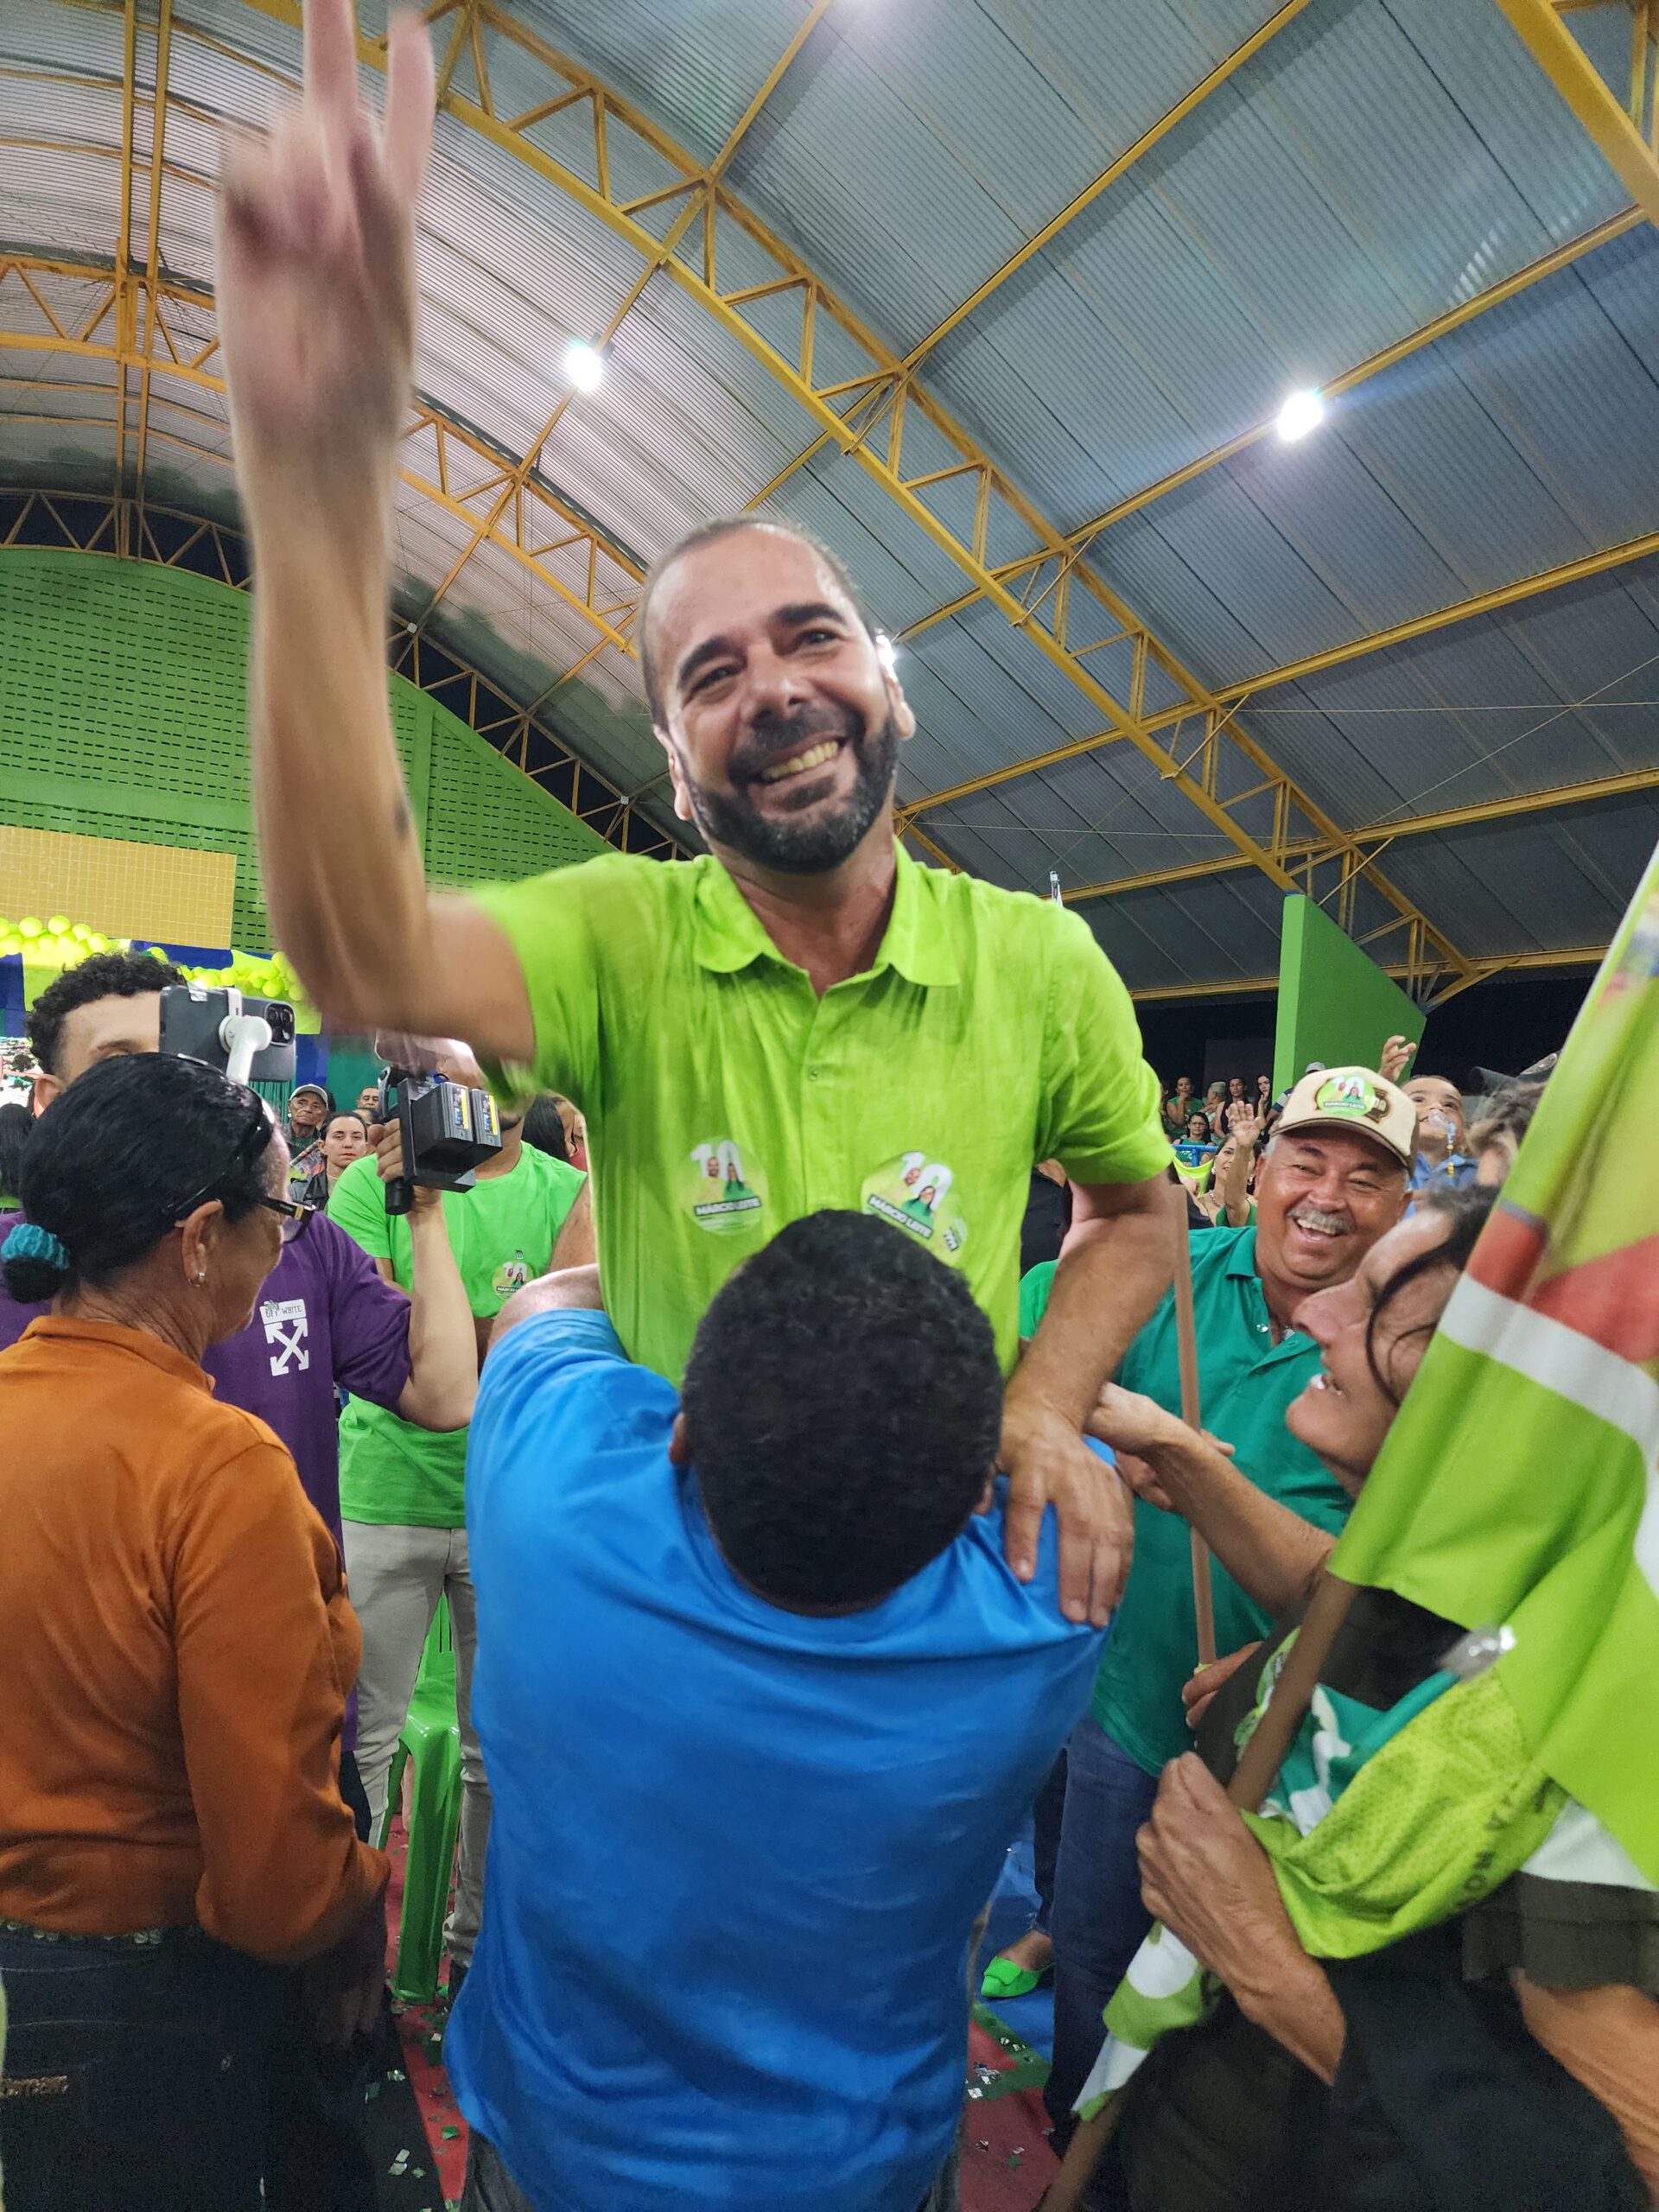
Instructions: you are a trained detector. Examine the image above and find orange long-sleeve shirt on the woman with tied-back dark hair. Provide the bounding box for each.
[0,1319,387,1962]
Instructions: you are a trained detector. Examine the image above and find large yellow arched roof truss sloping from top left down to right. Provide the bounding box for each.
[200,0,1471,988]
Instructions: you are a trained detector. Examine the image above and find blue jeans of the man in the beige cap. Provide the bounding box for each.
[1044,1714,1157,2148]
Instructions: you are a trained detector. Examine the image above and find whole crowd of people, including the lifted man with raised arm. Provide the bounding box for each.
[0,0,1659,2212]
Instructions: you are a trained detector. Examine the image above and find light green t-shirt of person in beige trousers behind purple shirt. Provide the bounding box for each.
[327,1144,582,1529]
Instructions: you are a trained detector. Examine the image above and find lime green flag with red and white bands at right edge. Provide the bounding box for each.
[1332,836,1659,1880]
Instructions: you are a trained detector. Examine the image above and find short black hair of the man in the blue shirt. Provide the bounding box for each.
[681,1212,1002,1608]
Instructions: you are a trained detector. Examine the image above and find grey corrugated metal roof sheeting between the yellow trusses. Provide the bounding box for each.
[0,0,1659,988]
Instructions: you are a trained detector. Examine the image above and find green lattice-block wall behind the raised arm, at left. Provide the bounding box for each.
[0,546,606,953]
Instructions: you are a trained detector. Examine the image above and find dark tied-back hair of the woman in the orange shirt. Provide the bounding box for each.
[4,1053,276,1305]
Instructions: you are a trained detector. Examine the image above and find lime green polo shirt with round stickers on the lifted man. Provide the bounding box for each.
[474,852,1170,1382]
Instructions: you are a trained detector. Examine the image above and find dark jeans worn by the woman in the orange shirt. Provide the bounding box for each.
[0,1929,281,2212]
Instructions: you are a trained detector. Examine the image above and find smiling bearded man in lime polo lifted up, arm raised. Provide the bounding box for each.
[219,0,1168,1621]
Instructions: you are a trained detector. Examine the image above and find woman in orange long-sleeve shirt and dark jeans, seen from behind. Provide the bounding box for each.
[0,1053,387,2212]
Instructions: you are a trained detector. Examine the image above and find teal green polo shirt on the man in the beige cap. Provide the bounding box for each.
[1020,1225,1354,1774]
